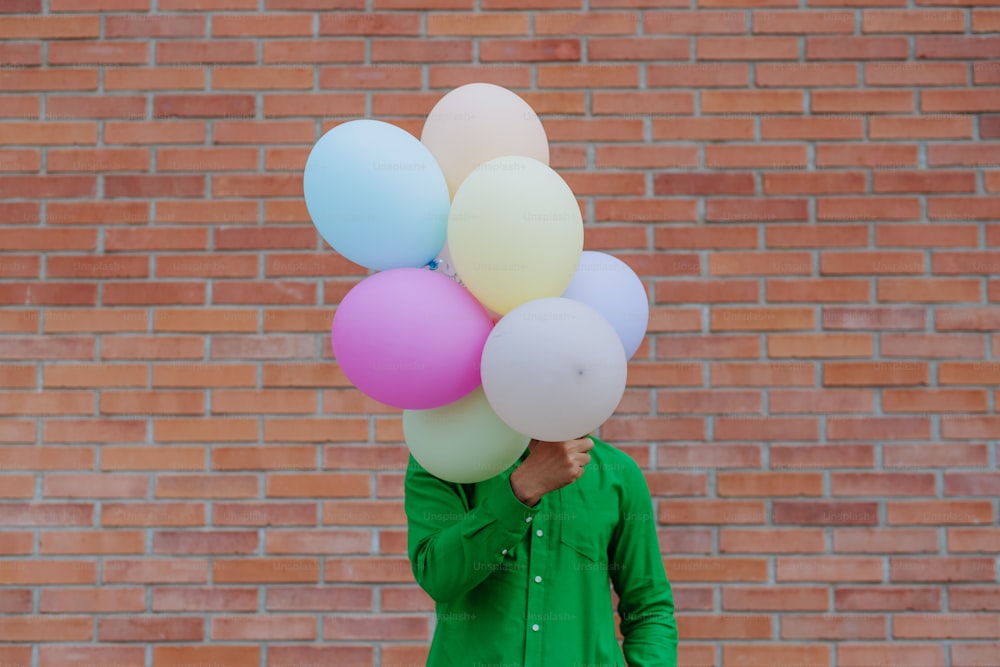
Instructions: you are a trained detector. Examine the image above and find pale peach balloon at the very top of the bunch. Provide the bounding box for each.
[420,83,549,197]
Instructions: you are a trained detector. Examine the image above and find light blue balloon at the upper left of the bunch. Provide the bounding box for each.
[303,119,451,271]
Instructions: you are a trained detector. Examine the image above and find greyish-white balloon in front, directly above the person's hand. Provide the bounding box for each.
[481,297,628,441]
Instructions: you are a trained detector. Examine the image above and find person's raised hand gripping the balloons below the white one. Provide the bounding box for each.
[510,438,594,507]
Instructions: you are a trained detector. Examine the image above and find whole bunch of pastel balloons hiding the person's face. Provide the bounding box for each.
[305,83,649,483]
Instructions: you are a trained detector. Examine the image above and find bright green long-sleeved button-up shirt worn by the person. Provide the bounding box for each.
[405,438,677,667]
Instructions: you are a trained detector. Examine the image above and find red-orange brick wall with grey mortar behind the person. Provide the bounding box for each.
[0,0,1000,667]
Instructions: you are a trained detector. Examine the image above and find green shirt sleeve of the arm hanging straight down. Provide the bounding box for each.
[609,462,677,667]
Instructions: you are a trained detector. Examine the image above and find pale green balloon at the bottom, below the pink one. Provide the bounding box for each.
[403,387,529,484]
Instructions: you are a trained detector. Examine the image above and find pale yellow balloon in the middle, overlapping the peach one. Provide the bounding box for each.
[448,156,583,315]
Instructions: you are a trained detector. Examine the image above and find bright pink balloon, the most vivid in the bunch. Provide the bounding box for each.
[331,268,493,410]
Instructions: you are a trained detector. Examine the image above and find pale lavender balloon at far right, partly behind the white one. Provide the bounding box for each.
[563,250,649,359]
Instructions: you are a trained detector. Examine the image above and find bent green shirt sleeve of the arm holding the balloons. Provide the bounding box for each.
[404,455,539,602]
